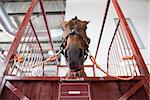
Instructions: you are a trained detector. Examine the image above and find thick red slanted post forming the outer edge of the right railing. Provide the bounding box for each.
[112,0,149,75]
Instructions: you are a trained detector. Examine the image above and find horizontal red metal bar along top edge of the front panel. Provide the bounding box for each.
[5,76,144,82]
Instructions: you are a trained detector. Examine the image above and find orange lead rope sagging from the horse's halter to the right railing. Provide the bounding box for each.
[88,52,136,81]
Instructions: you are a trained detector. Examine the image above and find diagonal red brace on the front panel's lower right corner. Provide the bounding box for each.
[119,80,143,100]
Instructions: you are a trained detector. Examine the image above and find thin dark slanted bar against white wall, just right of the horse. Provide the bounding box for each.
[95,0,110,58]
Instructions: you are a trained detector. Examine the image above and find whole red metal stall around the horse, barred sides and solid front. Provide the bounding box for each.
[0,0,150,100]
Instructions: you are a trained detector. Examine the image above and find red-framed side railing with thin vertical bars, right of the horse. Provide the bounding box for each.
[107,0,149,76]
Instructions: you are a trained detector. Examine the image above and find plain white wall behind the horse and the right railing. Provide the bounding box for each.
[65,0,150,75]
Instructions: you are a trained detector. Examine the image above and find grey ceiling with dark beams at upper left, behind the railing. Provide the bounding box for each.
[0,0,66,63]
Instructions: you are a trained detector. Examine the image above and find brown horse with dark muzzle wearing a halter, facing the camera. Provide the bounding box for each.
[61,17,90,77]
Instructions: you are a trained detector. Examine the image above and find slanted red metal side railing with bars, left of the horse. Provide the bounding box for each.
[4,0,54,76]
